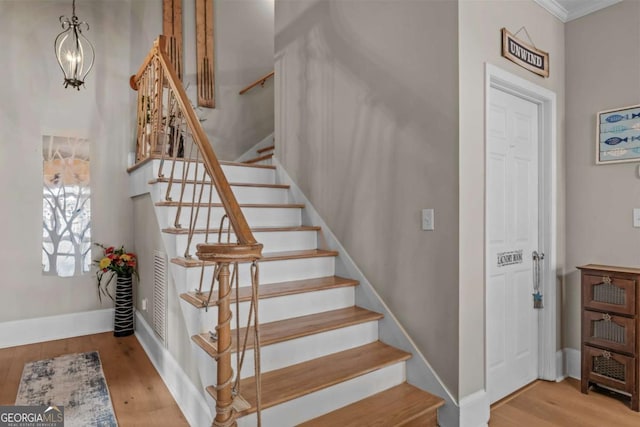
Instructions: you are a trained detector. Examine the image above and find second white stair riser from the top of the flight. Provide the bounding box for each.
[153,182,289,204]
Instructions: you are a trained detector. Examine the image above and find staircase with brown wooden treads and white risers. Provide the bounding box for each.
[132,36,443,427]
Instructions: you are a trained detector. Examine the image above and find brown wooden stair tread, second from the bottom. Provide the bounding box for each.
[207,341,411,416]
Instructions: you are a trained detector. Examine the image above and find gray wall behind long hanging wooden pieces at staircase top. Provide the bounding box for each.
[132,0,274,160]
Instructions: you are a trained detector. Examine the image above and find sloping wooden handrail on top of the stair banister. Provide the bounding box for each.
[131,36,258,251]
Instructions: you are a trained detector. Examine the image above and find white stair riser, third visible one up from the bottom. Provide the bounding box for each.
[193,287,355,333]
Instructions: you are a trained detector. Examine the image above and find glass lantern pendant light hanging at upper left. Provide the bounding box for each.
[55,0,95,90]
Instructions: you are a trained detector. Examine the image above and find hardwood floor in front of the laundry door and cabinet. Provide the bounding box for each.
[489,378,640,427]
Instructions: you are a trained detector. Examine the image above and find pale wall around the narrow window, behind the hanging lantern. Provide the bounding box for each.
[0,0,133,322]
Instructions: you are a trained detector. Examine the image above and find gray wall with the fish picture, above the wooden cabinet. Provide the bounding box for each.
[564,1,640,349]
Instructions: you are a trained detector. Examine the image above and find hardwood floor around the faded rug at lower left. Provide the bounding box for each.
[0,332,189,427]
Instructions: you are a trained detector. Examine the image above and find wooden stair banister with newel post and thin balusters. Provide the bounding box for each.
[130,36,262,427]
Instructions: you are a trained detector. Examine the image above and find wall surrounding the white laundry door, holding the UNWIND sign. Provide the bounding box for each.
[459,0,565,397]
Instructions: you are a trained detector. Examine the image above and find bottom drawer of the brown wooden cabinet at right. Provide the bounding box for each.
[582,345,636,393]
